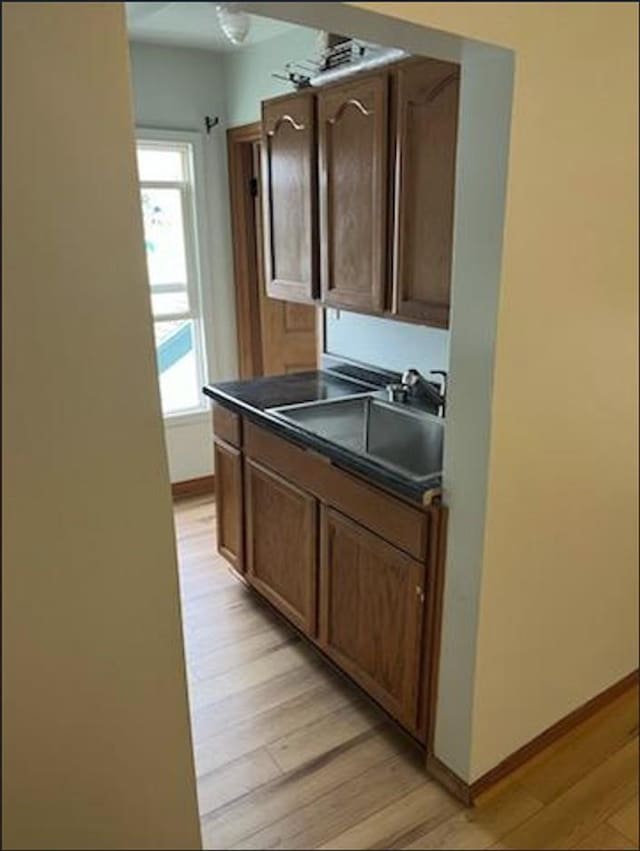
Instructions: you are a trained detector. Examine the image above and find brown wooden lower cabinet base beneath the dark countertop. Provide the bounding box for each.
[214,406,446,742]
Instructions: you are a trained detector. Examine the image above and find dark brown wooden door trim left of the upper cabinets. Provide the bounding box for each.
[227,121,262,378]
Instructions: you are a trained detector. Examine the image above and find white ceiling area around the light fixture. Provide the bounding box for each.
[124,2,304,52]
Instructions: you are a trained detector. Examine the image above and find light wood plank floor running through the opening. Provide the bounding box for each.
[176,498,638,849]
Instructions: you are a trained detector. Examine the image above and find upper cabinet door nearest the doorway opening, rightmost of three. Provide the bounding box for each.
[392,59,460,328]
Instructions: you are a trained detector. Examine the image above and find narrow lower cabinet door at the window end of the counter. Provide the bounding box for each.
[213,440,244,573]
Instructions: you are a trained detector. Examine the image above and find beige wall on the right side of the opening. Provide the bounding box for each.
[357,3,638,780]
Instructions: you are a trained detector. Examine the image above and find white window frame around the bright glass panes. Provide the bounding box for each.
[135,127,210,426]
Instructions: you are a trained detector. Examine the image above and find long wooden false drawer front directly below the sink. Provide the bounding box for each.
[244,422,429,561]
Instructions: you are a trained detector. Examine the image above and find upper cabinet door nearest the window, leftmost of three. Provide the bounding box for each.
[262,92,319,301]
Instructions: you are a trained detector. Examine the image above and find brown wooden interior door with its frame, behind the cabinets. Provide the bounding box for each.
[227,123,319,378]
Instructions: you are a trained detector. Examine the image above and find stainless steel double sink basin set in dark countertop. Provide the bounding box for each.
[270,395,444,480]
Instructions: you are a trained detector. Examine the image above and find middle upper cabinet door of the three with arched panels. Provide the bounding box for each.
[318,73,389,313]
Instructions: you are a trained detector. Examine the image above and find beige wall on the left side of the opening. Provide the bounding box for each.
[3,3,200,849]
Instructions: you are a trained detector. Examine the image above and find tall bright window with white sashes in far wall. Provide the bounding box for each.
[137,138,206,417]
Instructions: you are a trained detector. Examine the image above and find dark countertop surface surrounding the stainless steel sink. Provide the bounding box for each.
[203,370,442,505]
